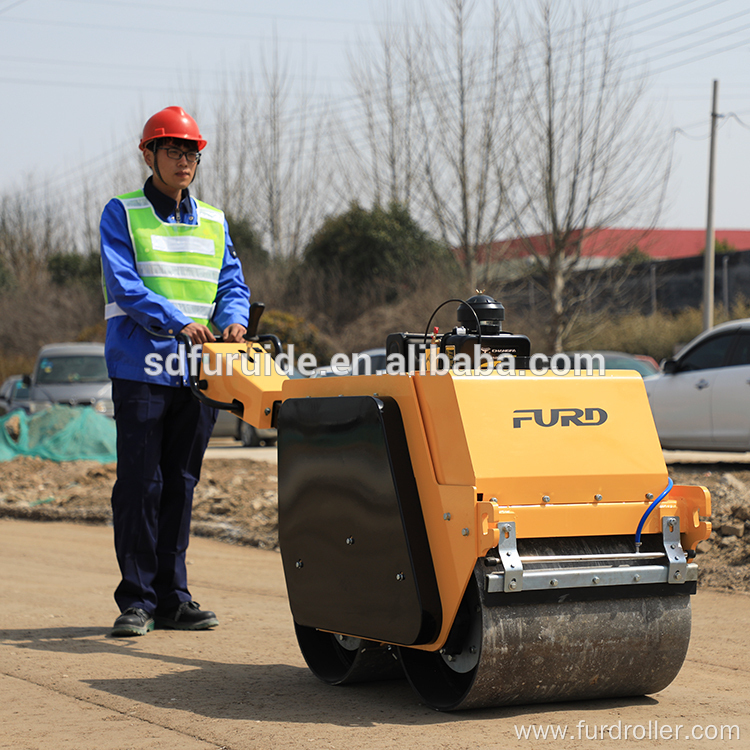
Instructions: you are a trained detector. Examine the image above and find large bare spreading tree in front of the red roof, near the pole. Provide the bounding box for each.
[503,0,669,352]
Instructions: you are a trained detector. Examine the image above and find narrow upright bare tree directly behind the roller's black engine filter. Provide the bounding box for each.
[420,0,516,291]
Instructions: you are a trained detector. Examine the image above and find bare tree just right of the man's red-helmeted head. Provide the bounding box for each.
[201,50,330,258]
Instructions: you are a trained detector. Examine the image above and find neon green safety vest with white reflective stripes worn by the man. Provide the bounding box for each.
[104,190,225,325]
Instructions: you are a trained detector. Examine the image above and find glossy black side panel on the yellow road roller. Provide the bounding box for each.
[279,396,441,645]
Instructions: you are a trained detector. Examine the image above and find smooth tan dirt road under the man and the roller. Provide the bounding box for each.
[0,519,750,750]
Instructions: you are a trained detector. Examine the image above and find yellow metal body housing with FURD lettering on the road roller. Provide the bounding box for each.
[274,372,711,650]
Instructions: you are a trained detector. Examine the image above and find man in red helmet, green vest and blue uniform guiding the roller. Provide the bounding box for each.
[100,107,250,636]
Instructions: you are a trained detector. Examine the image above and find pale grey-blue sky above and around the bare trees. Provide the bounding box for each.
[0,0,750,229]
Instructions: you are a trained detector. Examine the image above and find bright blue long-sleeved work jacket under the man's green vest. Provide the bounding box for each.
[99,177,250,386]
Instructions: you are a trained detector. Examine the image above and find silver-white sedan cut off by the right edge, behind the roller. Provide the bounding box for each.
[643,318,750,451]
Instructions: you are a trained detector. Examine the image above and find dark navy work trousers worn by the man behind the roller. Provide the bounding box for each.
[112,378,216,614]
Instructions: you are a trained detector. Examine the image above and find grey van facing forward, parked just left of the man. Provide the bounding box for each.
[23,343,114,417]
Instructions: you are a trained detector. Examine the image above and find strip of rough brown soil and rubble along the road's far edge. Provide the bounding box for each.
[0,457,750,592]
